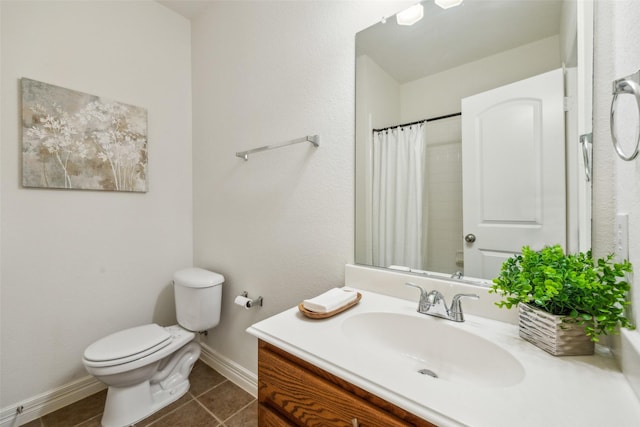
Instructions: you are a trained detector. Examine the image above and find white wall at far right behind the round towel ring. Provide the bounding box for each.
[593,0,640,397]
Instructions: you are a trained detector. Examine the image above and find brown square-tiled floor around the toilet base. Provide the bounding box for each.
[24,361,258,427]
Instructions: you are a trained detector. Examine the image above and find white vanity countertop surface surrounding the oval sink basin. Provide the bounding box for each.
[247,290,640,427]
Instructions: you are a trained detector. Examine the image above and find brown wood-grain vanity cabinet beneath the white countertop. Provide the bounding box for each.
[258,340,435,427]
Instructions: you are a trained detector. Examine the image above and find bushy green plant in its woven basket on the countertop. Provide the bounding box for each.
[489,245,634,356]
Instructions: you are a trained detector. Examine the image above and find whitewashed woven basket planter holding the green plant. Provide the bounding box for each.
[518,303,594,356]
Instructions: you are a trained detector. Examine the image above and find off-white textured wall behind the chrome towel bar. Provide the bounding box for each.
[192,1,410,372]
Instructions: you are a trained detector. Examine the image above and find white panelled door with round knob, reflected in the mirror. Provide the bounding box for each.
[462,69,566,278]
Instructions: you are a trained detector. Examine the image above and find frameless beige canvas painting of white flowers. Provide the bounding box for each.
[21,78,147,192]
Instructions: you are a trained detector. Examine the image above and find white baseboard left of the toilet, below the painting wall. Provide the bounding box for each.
[0,375,106,427]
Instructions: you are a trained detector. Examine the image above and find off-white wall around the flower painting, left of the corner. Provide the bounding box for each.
[0,1,193,408]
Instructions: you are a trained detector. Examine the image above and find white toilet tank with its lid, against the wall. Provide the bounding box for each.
[173,268,224,332]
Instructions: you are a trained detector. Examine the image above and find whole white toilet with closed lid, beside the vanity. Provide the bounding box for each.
[82,268,224,427]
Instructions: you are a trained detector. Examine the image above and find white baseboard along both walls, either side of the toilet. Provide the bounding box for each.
[0,343,258,427]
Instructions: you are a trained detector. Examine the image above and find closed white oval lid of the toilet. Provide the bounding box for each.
[84,323,171,364]
